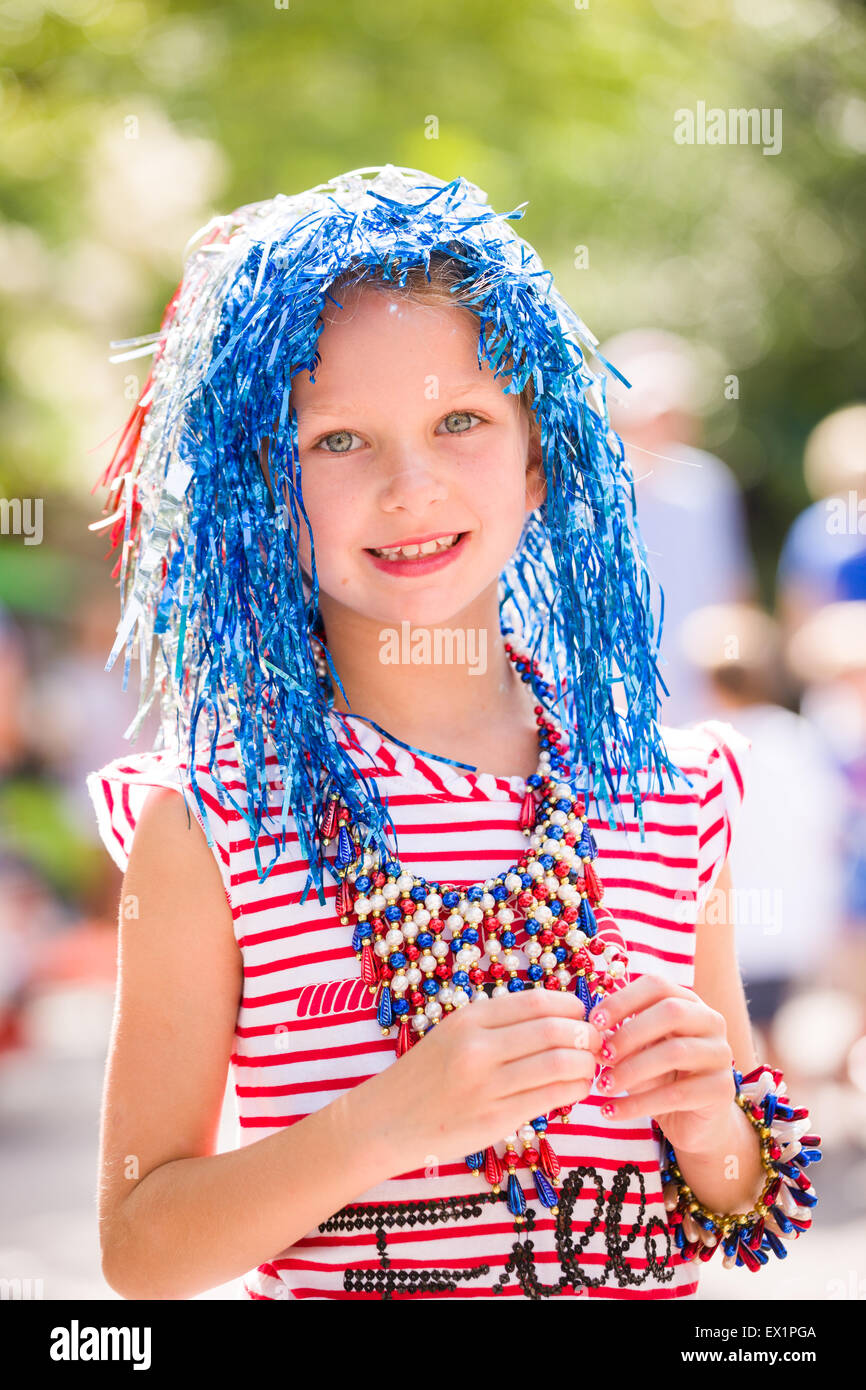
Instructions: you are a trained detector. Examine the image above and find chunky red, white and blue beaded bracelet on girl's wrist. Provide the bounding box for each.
[652,1066,822,1270]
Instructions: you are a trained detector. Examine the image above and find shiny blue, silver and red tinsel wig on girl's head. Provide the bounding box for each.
[93,164,678,901]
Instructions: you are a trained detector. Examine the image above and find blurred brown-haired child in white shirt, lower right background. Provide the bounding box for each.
[680,603,847,1086]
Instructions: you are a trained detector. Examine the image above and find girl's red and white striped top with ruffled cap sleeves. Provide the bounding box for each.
[88,713,751,1300]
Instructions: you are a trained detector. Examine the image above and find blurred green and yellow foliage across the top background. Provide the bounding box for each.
[0,0,866,598]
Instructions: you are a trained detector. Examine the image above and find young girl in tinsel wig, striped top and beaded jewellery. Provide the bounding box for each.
[88,165,820,1300]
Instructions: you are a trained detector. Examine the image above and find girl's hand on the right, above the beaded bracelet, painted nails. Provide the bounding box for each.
[589,974,737,1154]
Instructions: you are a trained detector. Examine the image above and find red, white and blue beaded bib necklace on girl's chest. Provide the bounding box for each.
[316,642,628,1222]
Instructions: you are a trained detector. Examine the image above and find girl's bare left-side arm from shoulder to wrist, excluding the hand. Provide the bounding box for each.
[99,790,397,1298]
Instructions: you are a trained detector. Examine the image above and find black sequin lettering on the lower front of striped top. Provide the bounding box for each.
[318,1163,674,1300]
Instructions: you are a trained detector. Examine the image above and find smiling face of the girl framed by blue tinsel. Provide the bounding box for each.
[271,286,544,624]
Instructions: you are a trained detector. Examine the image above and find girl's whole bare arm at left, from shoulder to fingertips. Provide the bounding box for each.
[99,790,601,1298]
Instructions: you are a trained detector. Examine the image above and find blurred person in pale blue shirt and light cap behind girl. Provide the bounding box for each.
[601,328,755,724]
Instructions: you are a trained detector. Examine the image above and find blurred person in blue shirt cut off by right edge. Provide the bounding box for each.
[776,403,866,635]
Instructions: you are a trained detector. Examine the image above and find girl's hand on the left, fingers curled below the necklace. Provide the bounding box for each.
[367,990,602,1173]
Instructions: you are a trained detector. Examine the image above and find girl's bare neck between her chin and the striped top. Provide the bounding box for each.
[315,592,535,767]
